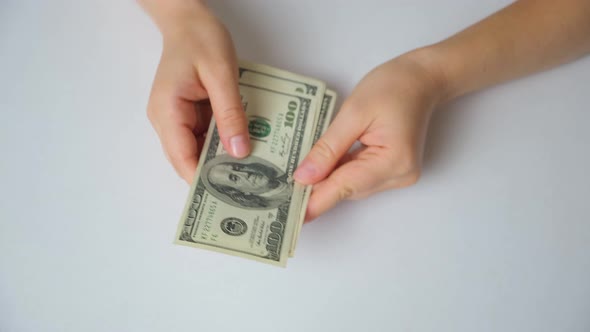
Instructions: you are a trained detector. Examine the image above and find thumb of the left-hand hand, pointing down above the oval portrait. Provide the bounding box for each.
[202,65,250,158]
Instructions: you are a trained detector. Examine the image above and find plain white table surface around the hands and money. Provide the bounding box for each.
[0,0,590,332]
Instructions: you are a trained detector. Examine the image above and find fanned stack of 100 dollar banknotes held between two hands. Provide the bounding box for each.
[175,62,336,266]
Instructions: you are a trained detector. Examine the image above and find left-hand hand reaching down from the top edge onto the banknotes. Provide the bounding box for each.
[143,0,250,184]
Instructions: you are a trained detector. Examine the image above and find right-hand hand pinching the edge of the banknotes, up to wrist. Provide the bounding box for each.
[295,52,443,221]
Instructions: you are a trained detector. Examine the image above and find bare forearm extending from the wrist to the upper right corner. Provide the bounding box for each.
[426,0,590,100]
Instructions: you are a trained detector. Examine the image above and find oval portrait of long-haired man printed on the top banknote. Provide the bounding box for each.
[201,155,293,210]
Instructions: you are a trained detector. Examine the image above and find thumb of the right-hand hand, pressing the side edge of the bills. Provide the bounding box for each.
[294,105,365,184]
